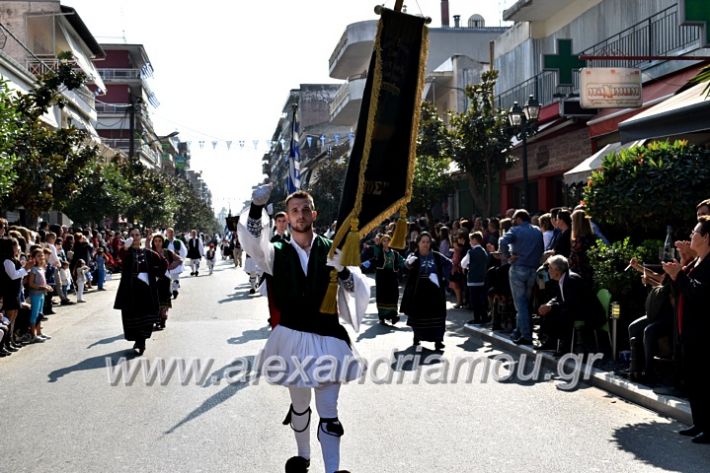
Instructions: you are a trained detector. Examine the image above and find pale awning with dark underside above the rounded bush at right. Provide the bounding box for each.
[619,84,710,143]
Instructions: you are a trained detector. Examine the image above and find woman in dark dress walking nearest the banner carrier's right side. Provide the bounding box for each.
[374,235,404,325]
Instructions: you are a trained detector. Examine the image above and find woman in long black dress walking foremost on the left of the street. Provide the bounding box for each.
[113,228,168,355]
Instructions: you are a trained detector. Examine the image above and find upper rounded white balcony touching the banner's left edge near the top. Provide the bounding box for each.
[329,20,377,79]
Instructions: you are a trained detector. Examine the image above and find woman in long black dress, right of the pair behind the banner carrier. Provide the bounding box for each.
[400,232,451,350]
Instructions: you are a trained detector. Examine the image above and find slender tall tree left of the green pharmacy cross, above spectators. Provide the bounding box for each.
[449,71,513,215]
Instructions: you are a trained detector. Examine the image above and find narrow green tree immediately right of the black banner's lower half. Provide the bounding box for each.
[408,102,454,221]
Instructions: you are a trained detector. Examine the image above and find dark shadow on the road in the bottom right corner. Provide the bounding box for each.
[611,422,710,473]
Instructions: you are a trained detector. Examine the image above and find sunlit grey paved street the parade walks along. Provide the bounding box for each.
[0,263,710,473]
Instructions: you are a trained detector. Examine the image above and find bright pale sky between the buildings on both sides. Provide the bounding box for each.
[62,0,515,212]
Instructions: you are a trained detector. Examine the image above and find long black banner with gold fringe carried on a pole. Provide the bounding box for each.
[334,8,428,247]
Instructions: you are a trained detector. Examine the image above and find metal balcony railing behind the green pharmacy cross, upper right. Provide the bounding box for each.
[497,5,702,109]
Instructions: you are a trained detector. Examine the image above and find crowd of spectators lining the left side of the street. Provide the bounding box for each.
[0,218,219,357]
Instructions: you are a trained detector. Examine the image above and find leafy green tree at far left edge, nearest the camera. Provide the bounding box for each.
[0,53,98,219]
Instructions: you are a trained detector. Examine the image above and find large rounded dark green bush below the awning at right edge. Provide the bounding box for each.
[584,141,710,242]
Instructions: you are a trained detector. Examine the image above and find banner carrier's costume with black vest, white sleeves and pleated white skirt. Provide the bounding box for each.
[238,204,370,473]
